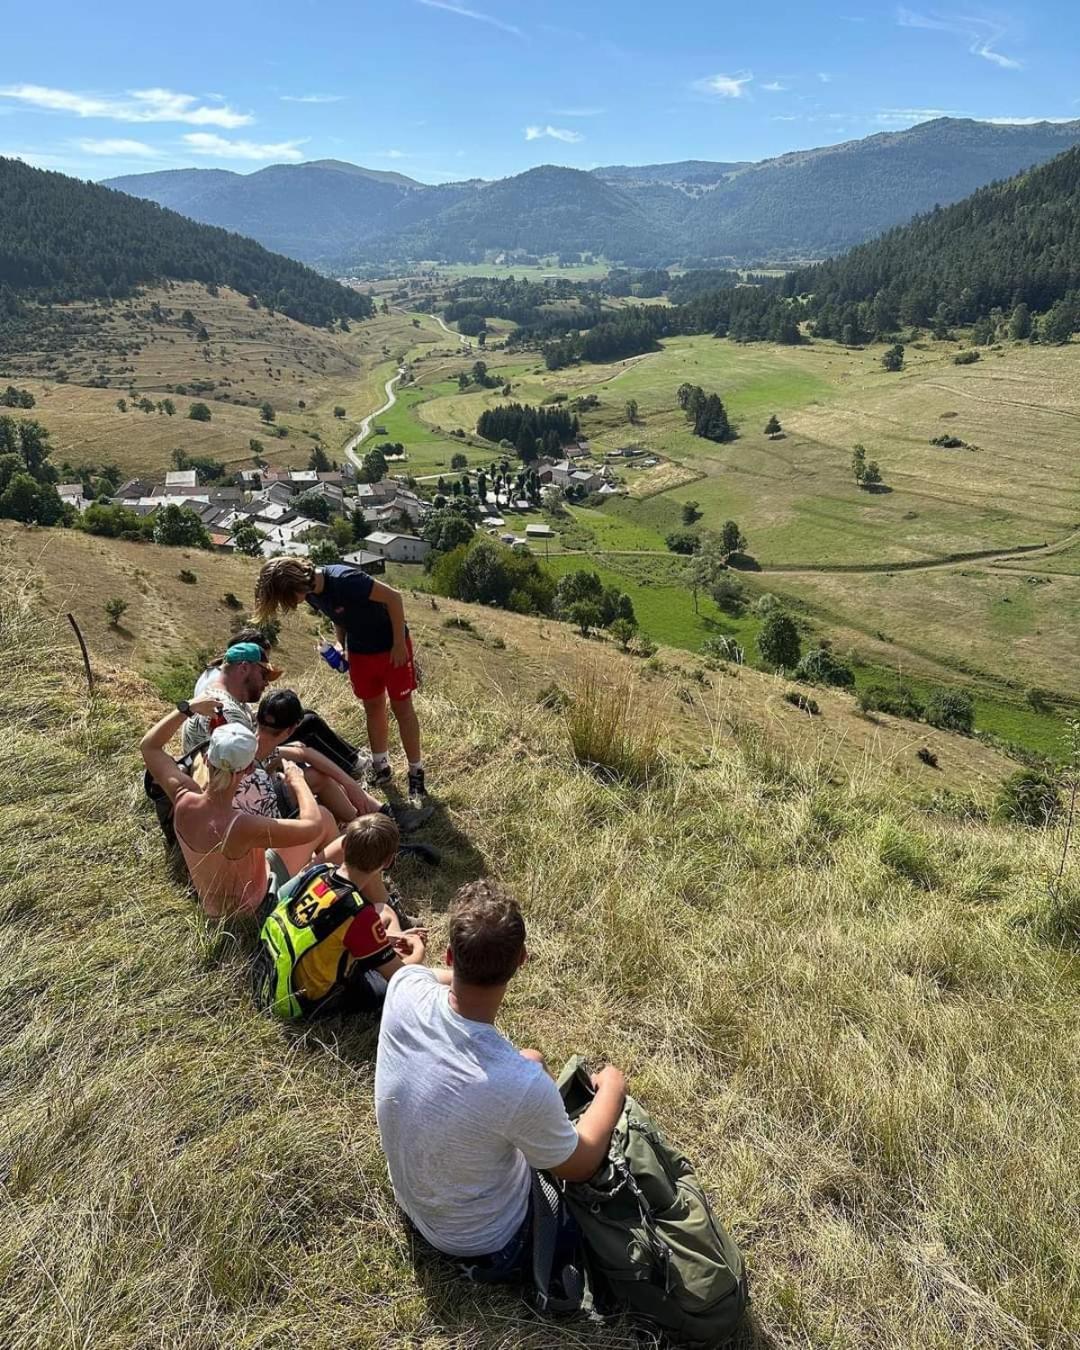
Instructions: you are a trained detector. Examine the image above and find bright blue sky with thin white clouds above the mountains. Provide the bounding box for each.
[0,0,1080,182]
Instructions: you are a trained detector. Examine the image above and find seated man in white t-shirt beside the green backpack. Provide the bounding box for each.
[375,882,626,1276]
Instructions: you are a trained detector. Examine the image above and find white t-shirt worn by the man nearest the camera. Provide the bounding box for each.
[375,965,578,1257]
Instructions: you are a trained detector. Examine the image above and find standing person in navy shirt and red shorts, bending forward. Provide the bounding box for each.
[255,558,427,798]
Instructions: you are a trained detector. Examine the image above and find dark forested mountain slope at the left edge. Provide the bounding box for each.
[0,159,371,324]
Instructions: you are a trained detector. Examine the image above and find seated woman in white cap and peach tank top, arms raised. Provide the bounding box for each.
[139,695,340,918]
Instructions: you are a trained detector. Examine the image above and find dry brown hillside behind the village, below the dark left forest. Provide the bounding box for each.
[0,292,446,477]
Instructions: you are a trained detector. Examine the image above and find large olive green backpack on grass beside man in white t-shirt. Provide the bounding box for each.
[548,1057,747,1346]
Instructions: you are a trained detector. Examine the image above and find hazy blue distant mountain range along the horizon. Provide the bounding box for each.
[104,117,1080,270]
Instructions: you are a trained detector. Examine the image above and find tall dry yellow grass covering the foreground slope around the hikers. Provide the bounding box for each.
[0,545,1080,1350]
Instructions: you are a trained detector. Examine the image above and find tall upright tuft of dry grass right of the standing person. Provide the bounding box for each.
[563,663,660,787]
